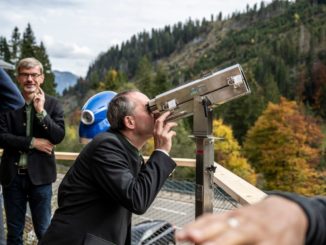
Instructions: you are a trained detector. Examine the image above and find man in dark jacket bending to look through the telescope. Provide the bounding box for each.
[40,91,177,245]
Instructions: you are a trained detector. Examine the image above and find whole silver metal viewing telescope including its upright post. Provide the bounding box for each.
[147,64,250,217]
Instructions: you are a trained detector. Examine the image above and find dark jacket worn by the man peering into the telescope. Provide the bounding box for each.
[40,129,176,245]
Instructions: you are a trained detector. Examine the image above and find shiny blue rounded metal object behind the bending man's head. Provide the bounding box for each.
[79,91,117,144]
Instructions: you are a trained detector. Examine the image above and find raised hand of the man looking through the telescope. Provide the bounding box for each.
[153,111,178,153]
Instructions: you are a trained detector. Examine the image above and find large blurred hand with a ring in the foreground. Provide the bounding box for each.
[176,196,308,245]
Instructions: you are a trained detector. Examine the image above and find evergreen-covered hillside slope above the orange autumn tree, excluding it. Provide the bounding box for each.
[66,1,326,141]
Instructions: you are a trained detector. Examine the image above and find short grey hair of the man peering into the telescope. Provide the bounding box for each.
[107,90,138,131]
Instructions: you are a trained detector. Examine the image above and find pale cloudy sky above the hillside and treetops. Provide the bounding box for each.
[0,0,271,77]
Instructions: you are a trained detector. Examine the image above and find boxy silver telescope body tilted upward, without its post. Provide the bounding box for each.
[148,64,250,121]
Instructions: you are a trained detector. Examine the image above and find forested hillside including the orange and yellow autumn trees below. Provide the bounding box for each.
[64,0,326,195]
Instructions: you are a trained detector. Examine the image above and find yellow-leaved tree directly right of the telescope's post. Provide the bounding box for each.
[213,119,256,184]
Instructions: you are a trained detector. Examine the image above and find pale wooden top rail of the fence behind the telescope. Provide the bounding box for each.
[0,149,266,205]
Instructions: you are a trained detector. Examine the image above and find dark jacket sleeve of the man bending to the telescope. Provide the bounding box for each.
[91,136,176,214]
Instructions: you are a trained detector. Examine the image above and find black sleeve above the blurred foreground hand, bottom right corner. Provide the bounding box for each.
[272,192,326,245]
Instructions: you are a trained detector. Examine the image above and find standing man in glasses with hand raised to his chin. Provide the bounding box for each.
[0,58,65,245]
